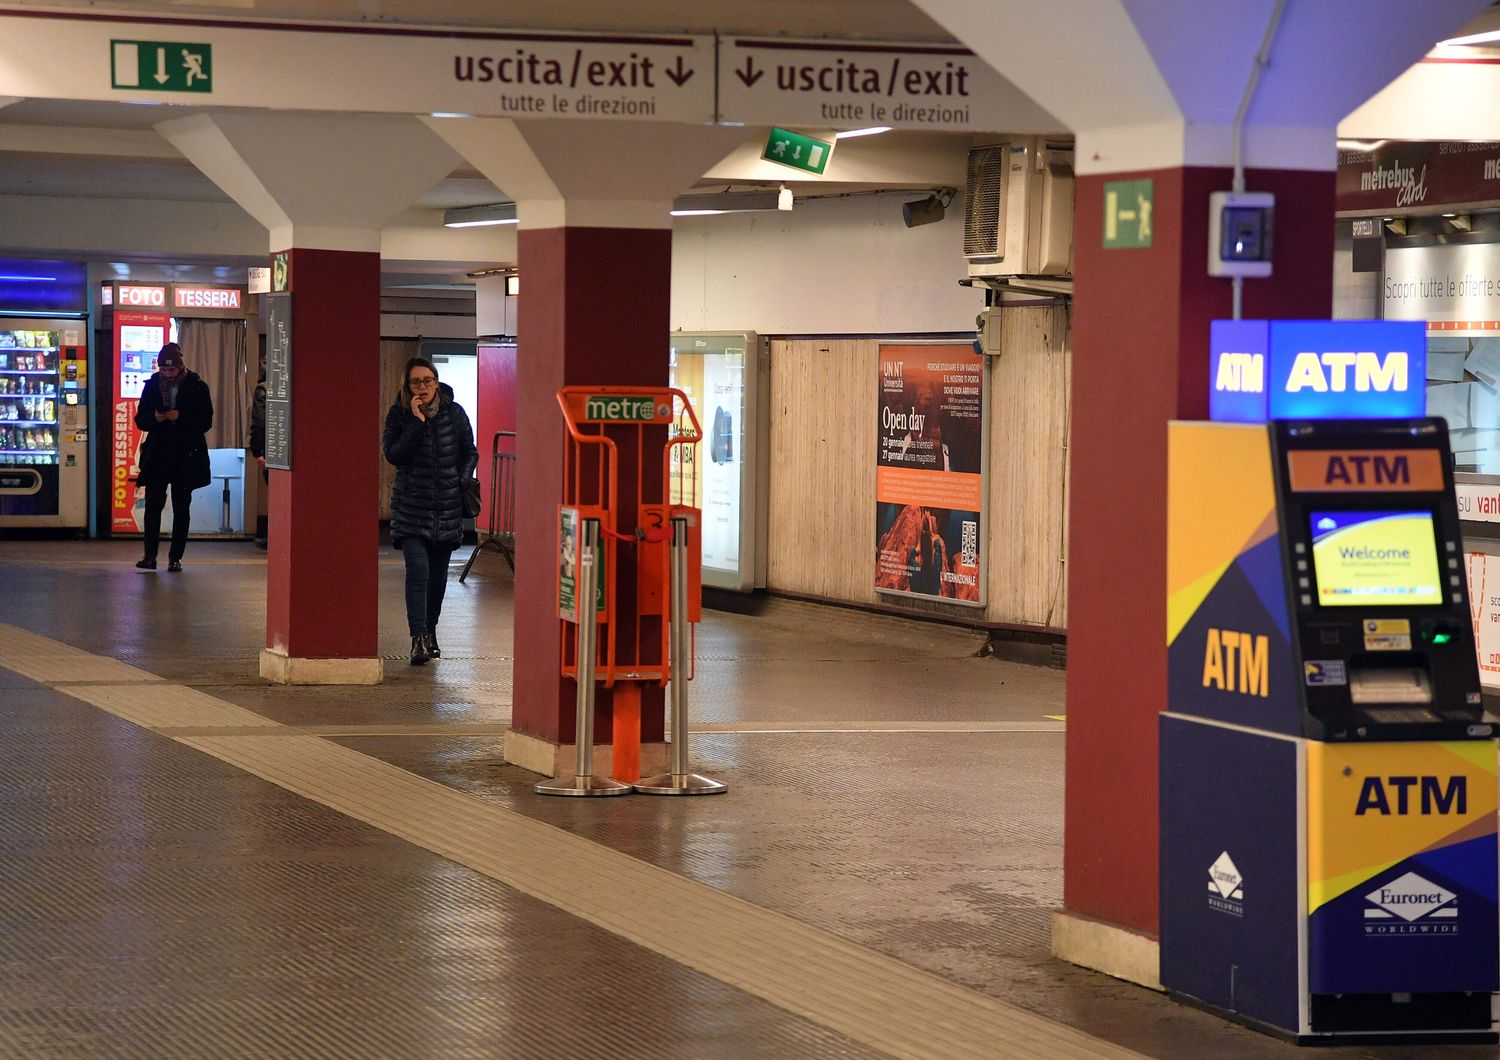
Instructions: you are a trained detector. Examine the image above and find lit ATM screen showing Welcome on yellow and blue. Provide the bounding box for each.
[1308,511,1443,607]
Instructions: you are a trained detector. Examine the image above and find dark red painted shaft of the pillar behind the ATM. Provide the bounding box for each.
[1064,168,1334,934]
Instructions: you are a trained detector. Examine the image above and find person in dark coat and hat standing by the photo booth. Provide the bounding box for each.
[135,342,213,571]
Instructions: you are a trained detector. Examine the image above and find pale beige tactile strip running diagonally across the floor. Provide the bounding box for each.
[0,627,1137,1059]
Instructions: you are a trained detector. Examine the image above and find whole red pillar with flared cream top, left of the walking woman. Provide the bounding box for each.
[158,112,461,684]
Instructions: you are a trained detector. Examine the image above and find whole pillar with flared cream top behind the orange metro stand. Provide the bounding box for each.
[428,118,744,777]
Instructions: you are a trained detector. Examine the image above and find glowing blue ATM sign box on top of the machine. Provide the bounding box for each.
[1209,321,1427,423]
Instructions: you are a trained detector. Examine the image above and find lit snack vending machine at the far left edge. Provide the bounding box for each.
[0,316,89,529]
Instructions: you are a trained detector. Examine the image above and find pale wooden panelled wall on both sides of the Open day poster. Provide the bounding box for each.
[768,306,1071,638]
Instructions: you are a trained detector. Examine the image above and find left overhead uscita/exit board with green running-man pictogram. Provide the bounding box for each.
[0,10,714,123]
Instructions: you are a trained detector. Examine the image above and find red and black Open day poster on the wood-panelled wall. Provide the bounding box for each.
[875,343,986,607]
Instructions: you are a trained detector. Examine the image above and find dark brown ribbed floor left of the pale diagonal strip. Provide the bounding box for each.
[0,687,876,1060]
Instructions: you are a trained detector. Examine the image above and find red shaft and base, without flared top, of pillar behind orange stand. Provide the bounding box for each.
[506,228,672,775]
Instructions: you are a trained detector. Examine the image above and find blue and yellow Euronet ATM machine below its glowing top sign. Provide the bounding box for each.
[1160,319,1500,1042]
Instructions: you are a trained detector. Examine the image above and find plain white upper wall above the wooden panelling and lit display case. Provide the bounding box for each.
[672,193,984,334]
